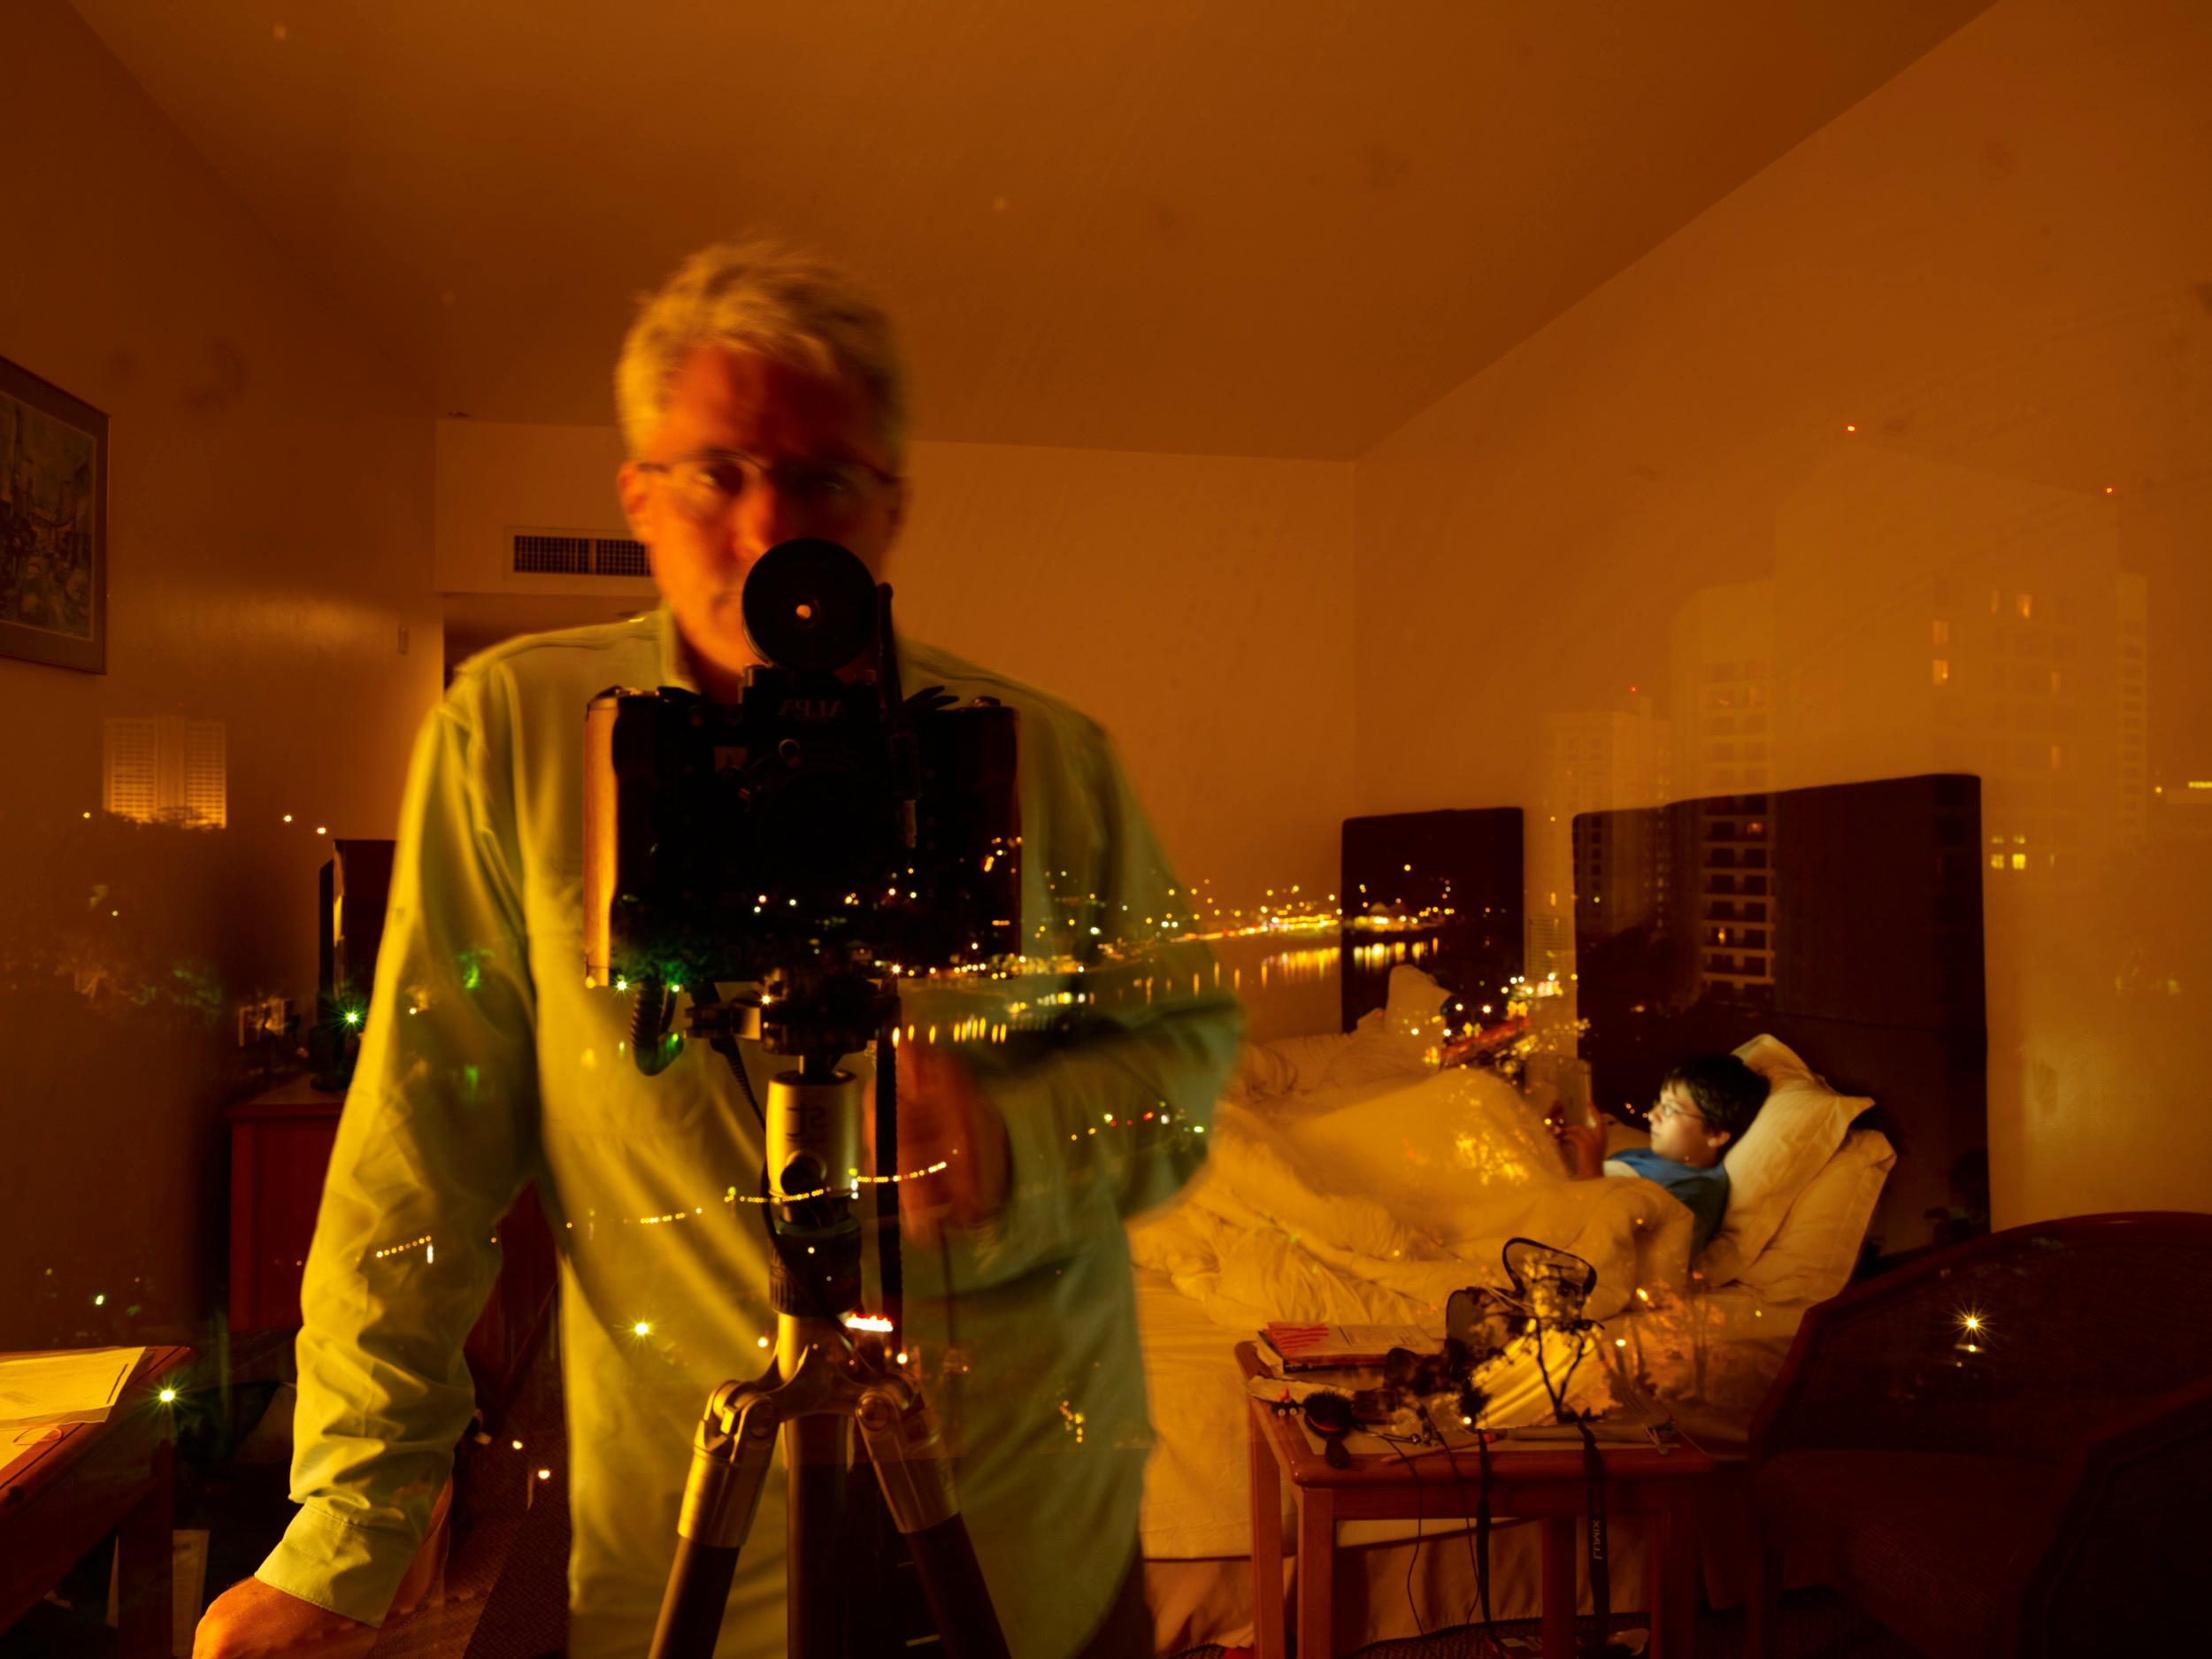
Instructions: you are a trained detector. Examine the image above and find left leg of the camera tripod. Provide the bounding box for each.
[649,1383,777,1659]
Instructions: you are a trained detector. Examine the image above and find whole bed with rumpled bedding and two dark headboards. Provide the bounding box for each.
[1131,779,1982,1655]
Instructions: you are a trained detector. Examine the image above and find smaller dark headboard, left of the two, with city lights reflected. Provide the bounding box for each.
[1339,808,1522,1031]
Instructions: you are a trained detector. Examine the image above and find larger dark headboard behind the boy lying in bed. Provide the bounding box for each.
[1575,774,1989,1255]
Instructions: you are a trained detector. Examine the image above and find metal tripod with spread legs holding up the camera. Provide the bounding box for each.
[637,972,1007,1659]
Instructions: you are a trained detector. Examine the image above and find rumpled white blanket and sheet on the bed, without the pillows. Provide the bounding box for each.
[1131,1071,1803,1560]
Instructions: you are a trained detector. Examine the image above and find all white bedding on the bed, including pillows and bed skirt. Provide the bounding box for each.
[1131,1009,1896,1653]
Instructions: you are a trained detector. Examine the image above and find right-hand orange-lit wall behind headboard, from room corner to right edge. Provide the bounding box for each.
[1356,0,2212,1225]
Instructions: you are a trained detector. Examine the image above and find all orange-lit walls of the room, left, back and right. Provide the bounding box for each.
[17,0,2212,1345]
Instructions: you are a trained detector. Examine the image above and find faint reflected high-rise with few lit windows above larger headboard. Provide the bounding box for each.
[1772,441,2148,883]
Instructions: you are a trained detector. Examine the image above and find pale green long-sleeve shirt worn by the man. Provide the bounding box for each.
[259,609,1241,1659]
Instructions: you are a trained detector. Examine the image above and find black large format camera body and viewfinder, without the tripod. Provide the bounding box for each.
[584,540,1022,1071]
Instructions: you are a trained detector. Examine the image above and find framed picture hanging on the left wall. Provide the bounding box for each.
[0,358,109,675]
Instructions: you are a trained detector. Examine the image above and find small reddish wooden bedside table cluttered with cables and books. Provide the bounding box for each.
[1237,1343,1715,1659]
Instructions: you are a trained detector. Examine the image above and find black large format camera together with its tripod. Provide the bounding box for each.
[584,540,1022,1659]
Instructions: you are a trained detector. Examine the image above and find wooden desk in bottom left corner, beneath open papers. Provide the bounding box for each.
[0,1348,193,1659]
